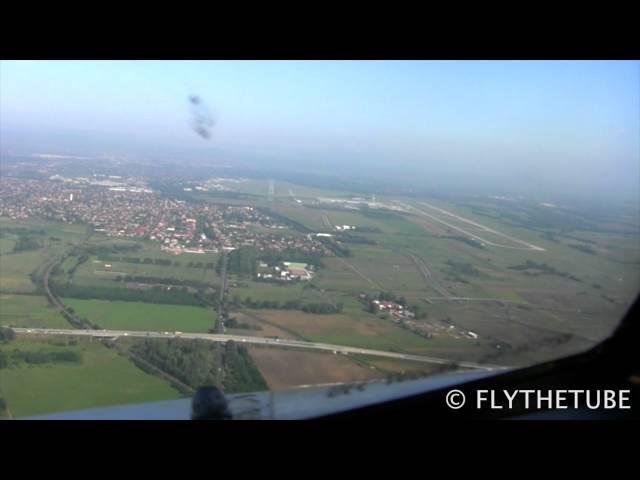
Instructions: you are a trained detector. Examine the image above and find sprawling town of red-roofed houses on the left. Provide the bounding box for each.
[0,175,329,256]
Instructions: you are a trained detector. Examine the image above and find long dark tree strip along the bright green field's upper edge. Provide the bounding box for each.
[50,282,215,307]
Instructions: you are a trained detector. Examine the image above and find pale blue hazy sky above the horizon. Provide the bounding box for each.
[0,61,640,201]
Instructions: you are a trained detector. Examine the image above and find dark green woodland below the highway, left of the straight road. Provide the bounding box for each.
[131,338,219,389]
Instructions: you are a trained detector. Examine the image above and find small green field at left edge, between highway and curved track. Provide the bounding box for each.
[0,293,70,328]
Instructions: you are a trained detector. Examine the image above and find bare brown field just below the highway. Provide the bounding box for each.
[249,347,384,390]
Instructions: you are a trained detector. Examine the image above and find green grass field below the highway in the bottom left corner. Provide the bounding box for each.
[0,338,181,418]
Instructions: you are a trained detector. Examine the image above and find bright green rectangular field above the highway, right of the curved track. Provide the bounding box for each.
[63,298,215,332]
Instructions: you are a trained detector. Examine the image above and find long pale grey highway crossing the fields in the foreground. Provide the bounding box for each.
[13,328,510,370]
